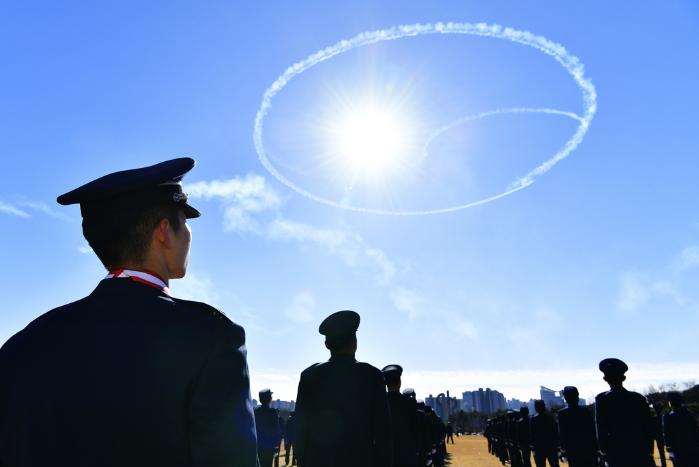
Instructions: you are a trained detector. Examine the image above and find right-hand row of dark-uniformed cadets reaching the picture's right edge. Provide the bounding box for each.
[483,359,699,467]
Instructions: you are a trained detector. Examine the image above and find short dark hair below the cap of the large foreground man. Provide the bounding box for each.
[83,204,181,269]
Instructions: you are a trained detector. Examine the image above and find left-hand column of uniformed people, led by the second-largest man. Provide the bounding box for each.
[255,310,454,467]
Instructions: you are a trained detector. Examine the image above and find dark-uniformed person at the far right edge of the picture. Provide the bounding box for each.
[663,392,699,467]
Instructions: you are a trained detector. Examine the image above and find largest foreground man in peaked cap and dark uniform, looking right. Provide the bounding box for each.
[0,158,257,467]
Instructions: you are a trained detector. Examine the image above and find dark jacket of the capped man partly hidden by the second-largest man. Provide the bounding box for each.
[387,391,419,467]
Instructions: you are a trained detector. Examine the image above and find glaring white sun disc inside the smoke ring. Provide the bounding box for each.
[332,104,408,176]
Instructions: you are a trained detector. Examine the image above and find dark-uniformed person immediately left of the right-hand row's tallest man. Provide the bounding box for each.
[558,386,597,467]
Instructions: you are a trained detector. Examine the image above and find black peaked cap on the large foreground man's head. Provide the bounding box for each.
[56,157,201,218]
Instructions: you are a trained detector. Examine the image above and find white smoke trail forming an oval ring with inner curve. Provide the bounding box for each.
[253,22,597,216]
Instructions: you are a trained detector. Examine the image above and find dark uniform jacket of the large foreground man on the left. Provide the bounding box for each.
[0,279,257,467]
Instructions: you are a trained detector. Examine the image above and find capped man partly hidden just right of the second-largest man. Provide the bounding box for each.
[381,365,419,467]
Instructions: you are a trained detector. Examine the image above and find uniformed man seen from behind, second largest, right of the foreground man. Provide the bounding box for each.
[296,310,392,467]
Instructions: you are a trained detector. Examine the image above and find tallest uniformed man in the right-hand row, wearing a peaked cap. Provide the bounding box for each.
[595,358,655,467]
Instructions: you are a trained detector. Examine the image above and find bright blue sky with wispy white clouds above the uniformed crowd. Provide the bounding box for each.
[0,1,699,399]
